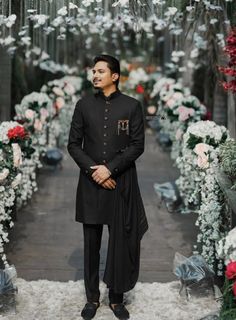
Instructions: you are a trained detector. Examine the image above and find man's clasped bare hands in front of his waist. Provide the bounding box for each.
[90,165,116,189]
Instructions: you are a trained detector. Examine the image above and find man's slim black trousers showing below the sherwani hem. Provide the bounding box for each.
[83,223,123,304]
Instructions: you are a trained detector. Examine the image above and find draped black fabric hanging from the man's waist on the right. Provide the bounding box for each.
[103,165,148,293]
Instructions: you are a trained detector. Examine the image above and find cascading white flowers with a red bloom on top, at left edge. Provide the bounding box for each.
[0,121,34,266]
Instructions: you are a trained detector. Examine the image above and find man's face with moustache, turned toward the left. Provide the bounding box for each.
[92,61,119,89]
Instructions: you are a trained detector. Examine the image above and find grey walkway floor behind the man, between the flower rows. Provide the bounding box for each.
[6,132,197,282]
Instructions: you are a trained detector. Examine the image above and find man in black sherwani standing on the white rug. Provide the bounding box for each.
[67,55,148,320]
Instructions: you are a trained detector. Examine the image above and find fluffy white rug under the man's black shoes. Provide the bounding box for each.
[0,278,219,320]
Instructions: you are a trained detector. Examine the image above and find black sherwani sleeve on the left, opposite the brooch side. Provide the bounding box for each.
[67,100,96,176]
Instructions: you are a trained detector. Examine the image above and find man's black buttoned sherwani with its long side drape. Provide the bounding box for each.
[67,89,148,292]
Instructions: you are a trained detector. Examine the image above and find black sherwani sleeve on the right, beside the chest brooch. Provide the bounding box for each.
[106,102,145,176]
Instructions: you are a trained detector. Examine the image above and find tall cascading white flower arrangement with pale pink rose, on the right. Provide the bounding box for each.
[176,120,229,275]
